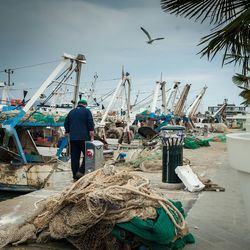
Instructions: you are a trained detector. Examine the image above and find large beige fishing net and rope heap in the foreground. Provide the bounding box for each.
[0,166,193,250]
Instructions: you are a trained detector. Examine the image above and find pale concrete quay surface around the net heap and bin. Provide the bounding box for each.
[0,142,250,250]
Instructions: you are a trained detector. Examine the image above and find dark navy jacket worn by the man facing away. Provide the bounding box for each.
[64,105,94,141]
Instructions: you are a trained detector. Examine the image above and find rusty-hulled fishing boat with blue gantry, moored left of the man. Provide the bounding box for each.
[0,54,86,192]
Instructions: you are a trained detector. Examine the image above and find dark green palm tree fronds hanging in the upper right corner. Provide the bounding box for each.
[161,0,250,105]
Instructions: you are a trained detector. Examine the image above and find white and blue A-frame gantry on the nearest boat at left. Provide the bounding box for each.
[0,54,86,164]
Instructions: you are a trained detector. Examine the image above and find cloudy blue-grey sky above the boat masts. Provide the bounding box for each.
[0,0,242,111]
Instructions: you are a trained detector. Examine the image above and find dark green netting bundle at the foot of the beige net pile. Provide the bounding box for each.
[112,201,195,250]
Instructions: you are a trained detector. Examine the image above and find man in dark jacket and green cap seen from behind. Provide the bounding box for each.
[64,100,94,180]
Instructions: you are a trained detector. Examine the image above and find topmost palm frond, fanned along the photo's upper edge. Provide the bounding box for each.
[161,0,250,24]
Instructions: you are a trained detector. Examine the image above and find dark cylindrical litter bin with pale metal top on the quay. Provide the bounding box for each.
[160,125,185,183]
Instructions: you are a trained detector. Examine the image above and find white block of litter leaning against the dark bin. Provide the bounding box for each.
[175,165,205,192]
